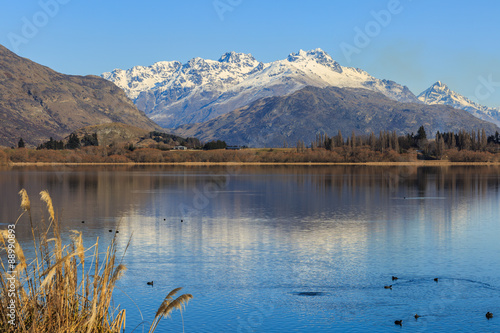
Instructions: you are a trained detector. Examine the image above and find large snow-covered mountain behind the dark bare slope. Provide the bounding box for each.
[101,49,419,128]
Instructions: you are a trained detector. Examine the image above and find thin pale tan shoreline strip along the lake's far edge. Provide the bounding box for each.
[5,160,500,167]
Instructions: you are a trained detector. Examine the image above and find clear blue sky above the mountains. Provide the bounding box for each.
[0,0,500,107]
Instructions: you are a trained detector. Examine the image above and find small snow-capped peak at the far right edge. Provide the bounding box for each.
[418,81,500,126]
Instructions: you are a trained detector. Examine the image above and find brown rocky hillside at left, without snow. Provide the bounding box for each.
[0,45,160,146]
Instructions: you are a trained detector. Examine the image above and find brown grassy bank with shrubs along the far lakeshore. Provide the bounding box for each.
[0,147,500,165]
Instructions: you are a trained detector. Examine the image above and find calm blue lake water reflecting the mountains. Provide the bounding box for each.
[0,166,500,332]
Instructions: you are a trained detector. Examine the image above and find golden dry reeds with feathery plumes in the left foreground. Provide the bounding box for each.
[0,189,192,333]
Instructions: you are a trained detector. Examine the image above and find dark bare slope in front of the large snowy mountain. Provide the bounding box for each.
[175,87,498,147]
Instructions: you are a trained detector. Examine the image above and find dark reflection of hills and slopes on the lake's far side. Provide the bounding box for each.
[0,166,500,240]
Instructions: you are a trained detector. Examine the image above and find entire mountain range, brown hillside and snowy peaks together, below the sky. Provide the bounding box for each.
[0,45,500,146]
